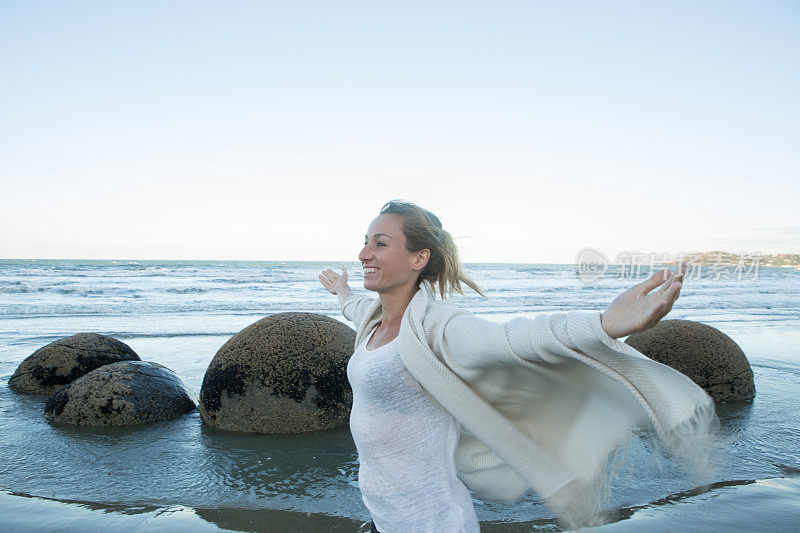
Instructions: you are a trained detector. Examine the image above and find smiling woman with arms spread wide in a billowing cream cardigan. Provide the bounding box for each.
[319,201,718,533]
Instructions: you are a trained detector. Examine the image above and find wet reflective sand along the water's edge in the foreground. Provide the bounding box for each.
[0,469,800,533]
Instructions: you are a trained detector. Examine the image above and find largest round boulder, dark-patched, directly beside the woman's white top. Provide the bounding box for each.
[198,312,356,433]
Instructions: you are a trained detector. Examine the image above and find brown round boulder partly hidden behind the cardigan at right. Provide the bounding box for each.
[625,320,756,402]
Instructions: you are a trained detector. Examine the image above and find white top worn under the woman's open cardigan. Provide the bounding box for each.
[347,327,480,533]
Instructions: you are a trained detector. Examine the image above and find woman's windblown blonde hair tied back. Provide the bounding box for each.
[379,200,487,299]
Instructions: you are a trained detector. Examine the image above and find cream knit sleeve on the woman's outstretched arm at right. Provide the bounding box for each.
[443,309,624,367]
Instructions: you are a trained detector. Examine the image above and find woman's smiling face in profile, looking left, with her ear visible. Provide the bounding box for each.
[358,214,430,293]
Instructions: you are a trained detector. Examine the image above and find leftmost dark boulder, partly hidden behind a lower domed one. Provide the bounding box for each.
[8,333,141,394]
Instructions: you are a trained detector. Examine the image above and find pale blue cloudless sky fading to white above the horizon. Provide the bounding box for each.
[0,0,800,263]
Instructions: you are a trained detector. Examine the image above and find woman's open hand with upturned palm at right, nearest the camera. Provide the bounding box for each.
[600,263,688,339]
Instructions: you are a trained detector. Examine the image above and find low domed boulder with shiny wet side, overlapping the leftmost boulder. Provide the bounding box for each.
[44,361,197,426]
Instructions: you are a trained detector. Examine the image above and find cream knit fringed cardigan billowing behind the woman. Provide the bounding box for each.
[342,282,719,507]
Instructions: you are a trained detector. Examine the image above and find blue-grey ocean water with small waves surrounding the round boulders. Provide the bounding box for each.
[0,259,800,531]
